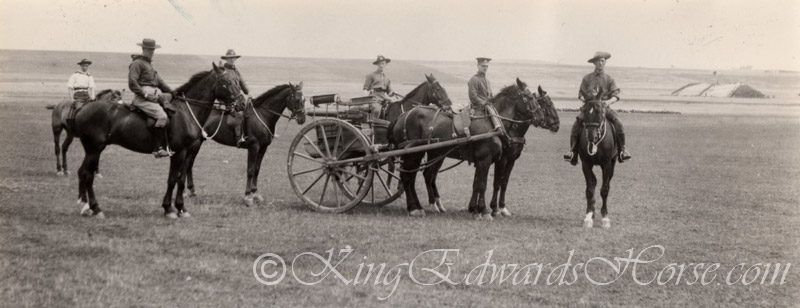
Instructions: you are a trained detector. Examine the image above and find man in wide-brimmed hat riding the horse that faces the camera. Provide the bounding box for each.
[564,51,631,166]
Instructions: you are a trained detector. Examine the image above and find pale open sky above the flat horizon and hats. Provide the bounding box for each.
[0,0,800,70]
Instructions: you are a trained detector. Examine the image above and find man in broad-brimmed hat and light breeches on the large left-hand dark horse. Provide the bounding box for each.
[128,38,172,158]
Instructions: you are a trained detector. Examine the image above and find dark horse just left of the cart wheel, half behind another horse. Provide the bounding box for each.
[186,82,306,206]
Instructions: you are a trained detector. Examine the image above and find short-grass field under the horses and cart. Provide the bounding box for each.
[0,49,800,307]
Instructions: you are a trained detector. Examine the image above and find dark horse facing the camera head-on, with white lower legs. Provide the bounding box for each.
[578,91,618,229]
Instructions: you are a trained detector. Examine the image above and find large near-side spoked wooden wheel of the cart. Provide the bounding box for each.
[287,119,375,213]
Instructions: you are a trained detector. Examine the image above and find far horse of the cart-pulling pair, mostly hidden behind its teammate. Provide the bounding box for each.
[489,86,560,217]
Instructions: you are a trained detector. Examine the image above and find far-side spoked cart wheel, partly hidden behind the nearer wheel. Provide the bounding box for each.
[342,157,403,206]
